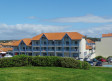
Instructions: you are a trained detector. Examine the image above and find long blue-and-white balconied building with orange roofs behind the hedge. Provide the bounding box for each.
[13,32,93,58]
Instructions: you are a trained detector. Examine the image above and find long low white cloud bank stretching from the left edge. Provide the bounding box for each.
[0,24,70,40]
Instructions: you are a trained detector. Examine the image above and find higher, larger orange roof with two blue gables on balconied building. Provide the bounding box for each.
[32,32,84,40]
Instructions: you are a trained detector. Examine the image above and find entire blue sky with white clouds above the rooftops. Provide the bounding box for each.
[0,0,112,40]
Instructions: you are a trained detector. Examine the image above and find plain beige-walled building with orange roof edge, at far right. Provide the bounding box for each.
[96,33,112,57]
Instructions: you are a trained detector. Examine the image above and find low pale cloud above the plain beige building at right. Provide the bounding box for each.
[68,24,112,37]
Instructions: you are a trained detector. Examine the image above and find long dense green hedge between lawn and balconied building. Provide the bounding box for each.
[0,55,90,69]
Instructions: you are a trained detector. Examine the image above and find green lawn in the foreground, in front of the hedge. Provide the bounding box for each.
[0,67,112,81]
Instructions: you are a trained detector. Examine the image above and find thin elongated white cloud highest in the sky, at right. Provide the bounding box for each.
[46,15,112,23]
